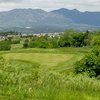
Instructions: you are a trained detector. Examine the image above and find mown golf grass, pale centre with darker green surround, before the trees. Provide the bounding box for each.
[2,48,85,71]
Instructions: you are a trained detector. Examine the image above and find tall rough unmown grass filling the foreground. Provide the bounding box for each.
[0,58,100,100]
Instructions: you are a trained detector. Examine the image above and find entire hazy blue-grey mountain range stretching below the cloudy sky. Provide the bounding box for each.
[0,8,100,33]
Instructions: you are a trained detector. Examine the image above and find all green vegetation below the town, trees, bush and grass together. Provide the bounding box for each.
[0,30,100,100]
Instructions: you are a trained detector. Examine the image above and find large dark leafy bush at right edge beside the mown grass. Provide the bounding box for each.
[75,49,100,77]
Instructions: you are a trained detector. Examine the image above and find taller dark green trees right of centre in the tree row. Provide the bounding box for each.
[59,31,89,47]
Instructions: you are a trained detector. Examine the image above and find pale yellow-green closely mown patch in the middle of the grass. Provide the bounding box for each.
[3,53,75,69]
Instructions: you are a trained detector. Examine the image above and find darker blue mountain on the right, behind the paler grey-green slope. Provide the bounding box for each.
[52,8,100,26]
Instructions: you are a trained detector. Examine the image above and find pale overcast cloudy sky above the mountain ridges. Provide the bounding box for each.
[0,0,100,11]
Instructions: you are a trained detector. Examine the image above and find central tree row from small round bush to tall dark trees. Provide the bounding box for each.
[23,30,90,48]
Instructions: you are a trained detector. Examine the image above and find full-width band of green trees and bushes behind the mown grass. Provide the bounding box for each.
[0,30,100,50]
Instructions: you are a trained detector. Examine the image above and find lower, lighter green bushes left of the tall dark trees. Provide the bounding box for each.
[23,36,59,48]
